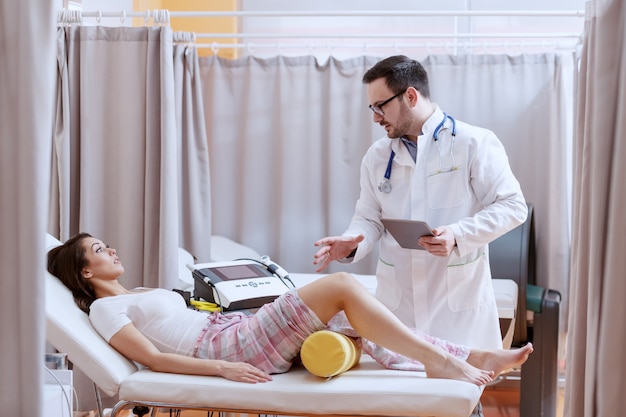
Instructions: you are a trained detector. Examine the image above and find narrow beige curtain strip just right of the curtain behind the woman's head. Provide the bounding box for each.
[174,39,212,262]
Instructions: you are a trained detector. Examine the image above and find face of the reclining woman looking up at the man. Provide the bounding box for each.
[82,237,124,280]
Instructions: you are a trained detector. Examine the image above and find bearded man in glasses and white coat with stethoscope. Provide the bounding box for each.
[314,56,527,349]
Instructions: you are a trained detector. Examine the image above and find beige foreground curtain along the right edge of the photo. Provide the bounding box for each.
[565,0,626,417]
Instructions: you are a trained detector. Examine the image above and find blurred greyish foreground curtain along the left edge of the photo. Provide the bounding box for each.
[0,0,55,417]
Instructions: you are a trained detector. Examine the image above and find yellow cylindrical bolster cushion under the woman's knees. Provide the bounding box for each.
[300,330,361,378]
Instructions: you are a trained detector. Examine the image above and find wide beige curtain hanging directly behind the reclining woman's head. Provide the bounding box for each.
[49,26,178,288]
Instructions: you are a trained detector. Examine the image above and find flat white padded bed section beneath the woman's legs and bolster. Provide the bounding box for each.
[119,355,482,417]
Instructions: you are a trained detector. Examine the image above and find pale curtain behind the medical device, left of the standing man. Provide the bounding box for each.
[200,56,379,272]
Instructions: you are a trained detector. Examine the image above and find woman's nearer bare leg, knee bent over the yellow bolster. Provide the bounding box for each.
[298,273,493,385]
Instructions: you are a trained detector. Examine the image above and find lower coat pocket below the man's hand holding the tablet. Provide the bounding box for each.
[447,254,489,312]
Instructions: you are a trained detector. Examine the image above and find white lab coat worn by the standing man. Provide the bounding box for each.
[344,108,527,349]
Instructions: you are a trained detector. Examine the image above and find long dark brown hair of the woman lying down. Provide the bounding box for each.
[48,233,96,314]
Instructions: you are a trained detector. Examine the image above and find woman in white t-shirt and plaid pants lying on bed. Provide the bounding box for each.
[48,233,532,385]
